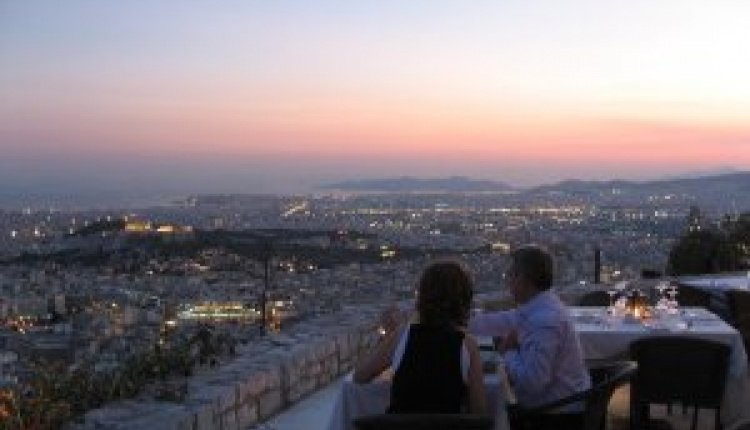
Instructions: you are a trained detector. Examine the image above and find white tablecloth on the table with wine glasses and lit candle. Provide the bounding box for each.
[571,307,750,426]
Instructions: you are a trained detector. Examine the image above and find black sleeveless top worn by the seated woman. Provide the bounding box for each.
[388,324,468,414]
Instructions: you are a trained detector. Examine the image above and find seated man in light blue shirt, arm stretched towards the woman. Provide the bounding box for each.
[469,245,591,408]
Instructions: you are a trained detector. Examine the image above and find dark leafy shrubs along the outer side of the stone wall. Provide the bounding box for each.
[0,328,234,430]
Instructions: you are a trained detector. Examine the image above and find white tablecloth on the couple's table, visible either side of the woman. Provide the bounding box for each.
[328,374,510,430]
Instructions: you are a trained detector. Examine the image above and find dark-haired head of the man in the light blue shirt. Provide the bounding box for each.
[507,245,554,303]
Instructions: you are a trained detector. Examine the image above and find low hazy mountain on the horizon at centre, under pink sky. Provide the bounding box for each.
[320,176,513,193]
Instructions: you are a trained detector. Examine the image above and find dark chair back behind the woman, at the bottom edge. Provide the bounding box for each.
[354,414,495,430]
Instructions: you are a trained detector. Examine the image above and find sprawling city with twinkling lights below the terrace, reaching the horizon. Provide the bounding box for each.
[0,174,750,424]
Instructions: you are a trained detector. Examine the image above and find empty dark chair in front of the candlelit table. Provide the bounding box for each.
[630,336,729,430]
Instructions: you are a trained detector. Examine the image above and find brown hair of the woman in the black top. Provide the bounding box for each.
[417,260,474,327]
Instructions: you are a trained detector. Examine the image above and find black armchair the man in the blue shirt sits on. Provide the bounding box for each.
[510,361,638,430]
